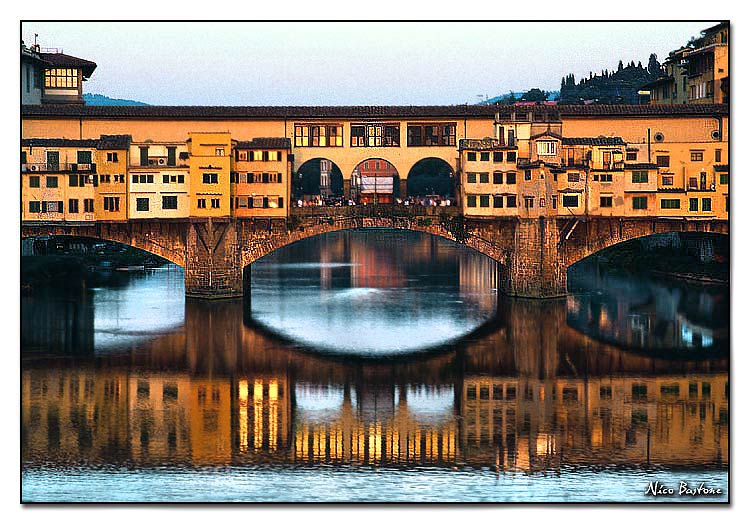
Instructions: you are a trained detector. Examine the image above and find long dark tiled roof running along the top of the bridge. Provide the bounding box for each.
[21,104,729,120]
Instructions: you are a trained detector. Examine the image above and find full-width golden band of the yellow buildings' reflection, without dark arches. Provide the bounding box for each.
[22,362,729,471]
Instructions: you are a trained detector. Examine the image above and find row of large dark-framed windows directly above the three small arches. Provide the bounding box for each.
[294,123,456,147]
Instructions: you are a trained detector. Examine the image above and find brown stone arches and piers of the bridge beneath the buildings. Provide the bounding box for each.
[21,206,729,299]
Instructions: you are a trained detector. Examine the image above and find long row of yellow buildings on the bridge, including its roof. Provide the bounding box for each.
[21,104,729,222]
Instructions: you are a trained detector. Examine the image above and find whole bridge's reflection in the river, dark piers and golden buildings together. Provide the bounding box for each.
[22,294,728,471]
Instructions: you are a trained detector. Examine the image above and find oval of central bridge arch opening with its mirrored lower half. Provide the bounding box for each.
[243,228,500,357]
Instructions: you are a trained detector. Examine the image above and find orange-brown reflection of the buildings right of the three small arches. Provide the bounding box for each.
[460,374,729,471]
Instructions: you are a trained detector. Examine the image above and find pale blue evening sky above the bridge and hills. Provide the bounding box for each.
[22,21,715,105]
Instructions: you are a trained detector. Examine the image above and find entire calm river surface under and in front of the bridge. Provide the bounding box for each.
[21,230,729,502]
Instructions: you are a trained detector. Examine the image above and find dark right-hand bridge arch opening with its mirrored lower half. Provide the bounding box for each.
[567,232,729,358]
